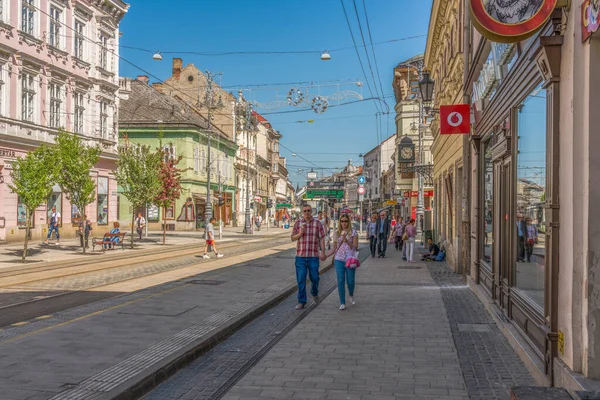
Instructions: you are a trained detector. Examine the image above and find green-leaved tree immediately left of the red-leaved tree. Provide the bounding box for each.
[115,145,162,248]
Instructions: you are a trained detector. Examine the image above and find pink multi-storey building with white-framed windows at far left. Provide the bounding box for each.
[0,0,129,241]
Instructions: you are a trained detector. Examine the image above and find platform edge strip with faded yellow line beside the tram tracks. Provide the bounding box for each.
[0,242,296,345]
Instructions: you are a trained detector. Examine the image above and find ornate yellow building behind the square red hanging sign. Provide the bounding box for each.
[425,0,469,272]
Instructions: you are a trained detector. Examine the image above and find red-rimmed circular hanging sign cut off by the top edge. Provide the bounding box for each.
[469,0,557,43]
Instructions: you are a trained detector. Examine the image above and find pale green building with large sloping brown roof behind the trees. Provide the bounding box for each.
[119,78,237,230]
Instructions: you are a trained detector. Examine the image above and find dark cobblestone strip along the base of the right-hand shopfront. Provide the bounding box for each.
[427,263,536,400]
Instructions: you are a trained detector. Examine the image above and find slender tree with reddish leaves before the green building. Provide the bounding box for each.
[154,141,181,245]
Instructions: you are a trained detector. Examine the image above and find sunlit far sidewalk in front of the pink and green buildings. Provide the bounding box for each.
[0,227,291,269]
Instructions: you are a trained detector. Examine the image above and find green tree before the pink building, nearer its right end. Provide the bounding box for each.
[51,130,102,254]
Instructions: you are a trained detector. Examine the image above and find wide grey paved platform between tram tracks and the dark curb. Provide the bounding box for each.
[0,242,329,400]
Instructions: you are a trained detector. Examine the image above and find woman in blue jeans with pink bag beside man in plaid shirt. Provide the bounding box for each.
[327,215,358,310]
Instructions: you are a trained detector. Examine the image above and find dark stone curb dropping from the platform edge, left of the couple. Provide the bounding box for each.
[52,257,333,400]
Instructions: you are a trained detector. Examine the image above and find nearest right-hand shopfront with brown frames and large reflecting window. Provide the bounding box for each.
[463,0,600,390]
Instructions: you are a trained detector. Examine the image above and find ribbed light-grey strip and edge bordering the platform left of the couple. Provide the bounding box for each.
[50,262,333,400]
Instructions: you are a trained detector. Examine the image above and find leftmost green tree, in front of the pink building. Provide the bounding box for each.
[8,145,55,263]
